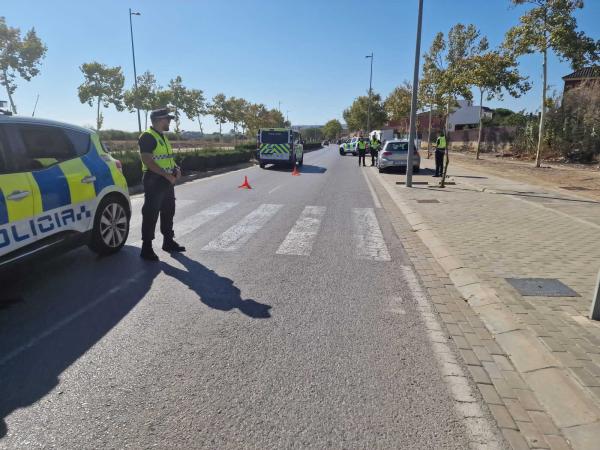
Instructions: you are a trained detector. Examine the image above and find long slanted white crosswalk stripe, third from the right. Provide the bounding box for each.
[202,204,283,252]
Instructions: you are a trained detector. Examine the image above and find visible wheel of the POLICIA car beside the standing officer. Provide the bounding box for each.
[89,196,129,255]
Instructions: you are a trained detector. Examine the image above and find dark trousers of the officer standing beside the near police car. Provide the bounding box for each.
[142,172,175,242]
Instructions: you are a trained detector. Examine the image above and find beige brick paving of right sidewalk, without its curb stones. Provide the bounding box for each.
[384,156,600,410]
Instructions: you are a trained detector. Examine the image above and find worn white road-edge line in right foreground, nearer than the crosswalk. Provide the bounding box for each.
[401,266,503,450]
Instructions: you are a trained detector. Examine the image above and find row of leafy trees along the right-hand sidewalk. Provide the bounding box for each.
[344,0,600,167]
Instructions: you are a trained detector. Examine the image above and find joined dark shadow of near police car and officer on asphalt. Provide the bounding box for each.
[0,247,271,440]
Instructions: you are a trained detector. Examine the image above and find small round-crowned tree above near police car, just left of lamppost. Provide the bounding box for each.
[78,62,125,130]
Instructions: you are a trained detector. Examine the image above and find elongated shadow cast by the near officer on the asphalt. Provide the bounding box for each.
[161,253,271,319]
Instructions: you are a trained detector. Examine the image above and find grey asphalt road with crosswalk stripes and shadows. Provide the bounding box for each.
[0,146,494,449]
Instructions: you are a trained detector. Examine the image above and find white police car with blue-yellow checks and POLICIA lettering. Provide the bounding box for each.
[0,114,131,270]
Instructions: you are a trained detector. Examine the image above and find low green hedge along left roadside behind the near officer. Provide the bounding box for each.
[111,146,255,187]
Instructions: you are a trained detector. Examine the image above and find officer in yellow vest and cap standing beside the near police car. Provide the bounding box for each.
[138,108,185,261]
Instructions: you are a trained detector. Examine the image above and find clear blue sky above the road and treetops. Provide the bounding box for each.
[0,0,600,131]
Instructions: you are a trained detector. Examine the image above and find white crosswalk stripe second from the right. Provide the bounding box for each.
[277,206,327,256]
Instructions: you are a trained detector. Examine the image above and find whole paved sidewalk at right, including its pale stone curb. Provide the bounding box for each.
[372,159,600,448]
